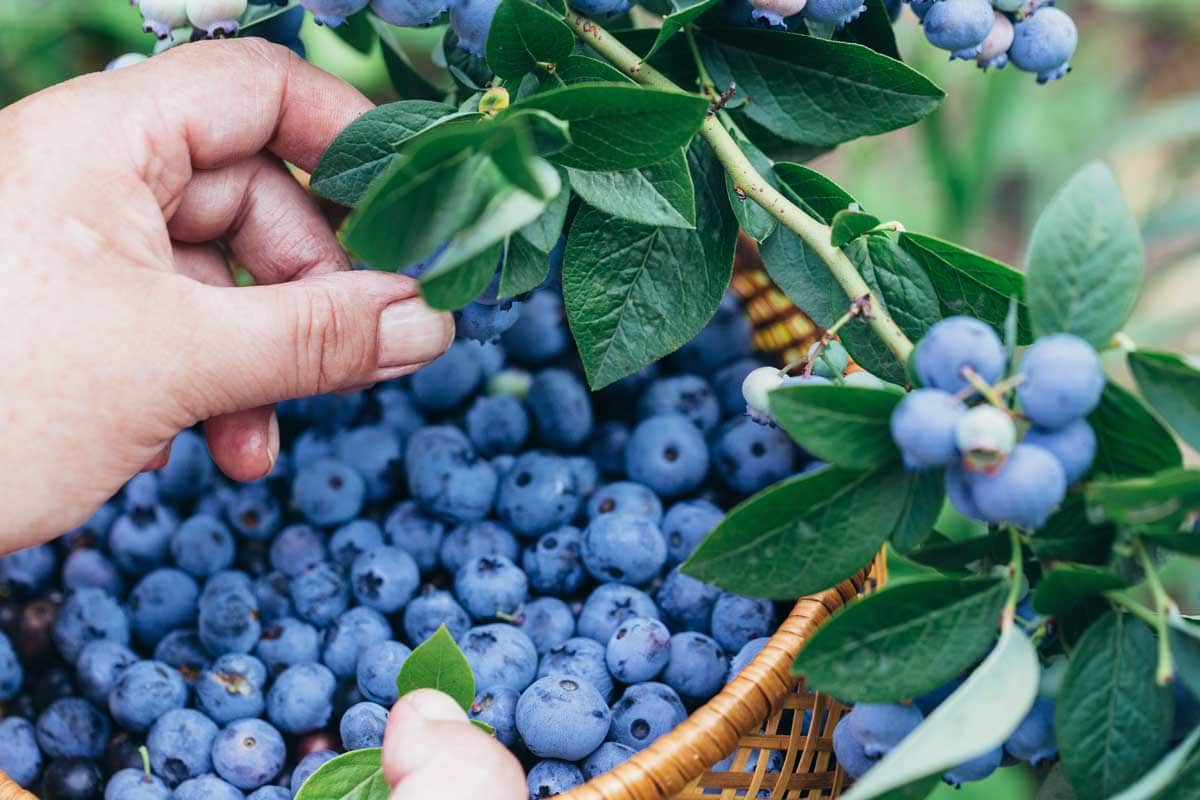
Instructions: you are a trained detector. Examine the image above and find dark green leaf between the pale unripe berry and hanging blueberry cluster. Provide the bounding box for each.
[770,385,904,469]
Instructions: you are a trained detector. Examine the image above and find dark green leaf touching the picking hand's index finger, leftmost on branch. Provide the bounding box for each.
[310,100,455,205]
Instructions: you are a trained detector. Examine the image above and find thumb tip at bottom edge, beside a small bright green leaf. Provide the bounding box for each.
[383,690,528,800]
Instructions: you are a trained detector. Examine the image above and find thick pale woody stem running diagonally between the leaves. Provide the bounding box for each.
[556,10,912,363]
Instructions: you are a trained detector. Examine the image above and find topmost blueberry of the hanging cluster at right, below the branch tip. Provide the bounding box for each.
[914,316,1008,393]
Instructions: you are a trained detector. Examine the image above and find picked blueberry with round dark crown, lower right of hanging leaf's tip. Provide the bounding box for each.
[625,414,708,497]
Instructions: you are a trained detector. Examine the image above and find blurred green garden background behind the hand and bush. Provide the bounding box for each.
[0,0,1200,800]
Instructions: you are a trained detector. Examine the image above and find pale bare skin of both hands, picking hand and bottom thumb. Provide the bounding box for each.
[0,38,526,800]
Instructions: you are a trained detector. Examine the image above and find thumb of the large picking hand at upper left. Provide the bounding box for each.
[176,270,454,419]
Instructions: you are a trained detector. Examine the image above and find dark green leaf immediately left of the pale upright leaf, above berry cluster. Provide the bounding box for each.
[900,233,1033,344]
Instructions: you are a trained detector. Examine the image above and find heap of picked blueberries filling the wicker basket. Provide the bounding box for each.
[0,272,820,800]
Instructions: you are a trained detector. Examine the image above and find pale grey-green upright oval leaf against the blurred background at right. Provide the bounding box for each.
[1025,163,1142,348]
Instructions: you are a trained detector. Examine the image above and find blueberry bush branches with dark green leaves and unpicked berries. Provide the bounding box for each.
[110,0,1200,800]
